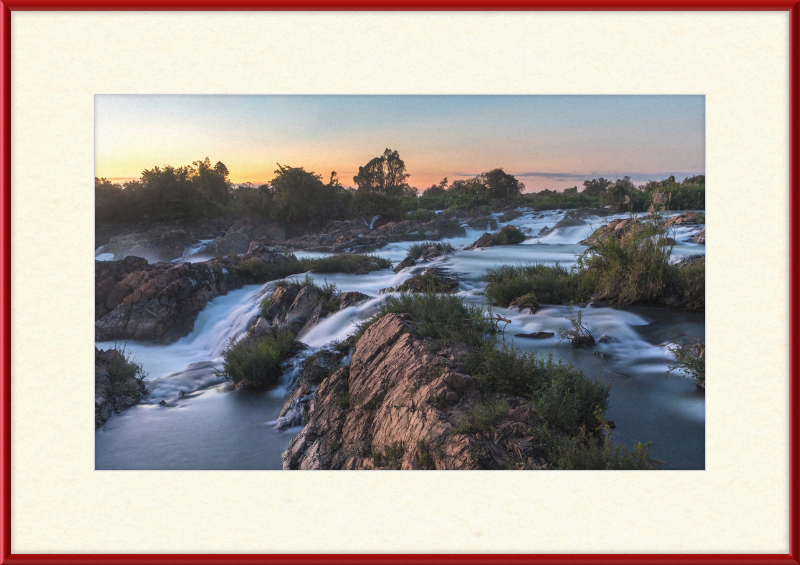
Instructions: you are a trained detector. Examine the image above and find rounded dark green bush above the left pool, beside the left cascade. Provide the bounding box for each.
[216,330,295,388]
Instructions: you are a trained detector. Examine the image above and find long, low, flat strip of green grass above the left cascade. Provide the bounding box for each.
[233,253,392,283]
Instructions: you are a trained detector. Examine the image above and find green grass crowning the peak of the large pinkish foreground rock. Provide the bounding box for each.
[356,294,494,345]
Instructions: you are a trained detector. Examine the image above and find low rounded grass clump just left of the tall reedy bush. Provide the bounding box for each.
[483,263,577,307]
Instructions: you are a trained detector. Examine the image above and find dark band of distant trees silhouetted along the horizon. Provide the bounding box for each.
[95,149,705,230]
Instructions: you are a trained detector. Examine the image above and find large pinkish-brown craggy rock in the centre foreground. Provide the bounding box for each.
[283,314,552,469]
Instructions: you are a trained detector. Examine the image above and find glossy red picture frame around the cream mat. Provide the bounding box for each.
[0,0,800,565]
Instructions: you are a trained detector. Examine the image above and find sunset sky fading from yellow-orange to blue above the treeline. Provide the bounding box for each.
[95,94,705,192]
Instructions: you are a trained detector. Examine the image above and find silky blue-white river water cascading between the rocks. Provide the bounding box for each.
[96,212,705,469]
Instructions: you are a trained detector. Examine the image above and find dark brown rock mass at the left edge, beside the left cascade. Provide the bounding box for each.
[95,257,238,343]
